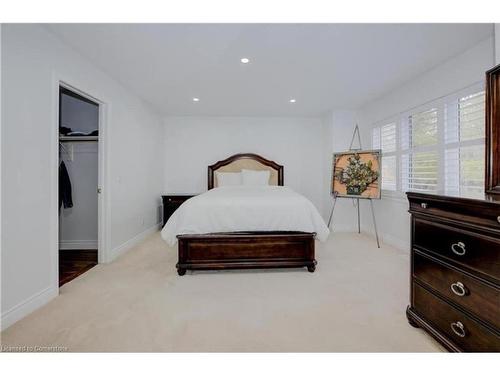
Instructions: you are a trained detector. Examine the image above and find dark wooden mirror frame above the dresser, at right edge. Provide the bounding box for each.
[485,65,500,194]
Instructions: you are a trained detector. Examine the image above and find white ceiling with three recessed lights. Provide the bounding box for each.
[48,24,493,116]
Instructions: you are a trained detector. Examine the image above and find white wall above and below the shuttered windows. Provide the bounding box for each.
[358,38,494,249]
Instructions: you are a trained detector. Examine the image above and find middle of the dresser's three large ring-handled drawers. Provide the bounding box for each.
[413,252,500,329]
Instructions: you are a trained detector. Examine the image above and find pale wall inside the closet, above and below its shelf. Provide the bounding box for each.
[59,95,99,250]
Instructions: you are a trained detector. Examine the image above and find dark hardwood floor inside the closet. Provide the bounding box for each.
[59,250,97,287]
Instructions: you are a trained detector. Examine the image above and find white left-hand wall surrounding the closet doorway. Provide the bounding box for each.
[1,25,163,328]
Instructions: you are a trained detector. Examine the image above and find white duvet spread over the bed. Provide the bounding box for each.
[161,186,330,246]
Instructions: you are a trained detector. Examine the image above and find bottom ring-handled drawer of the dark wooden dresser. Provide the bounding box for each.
[412,282,500,352]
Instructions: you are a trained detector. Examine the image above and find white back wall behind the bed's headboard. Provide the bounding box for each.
[164,117,324,214]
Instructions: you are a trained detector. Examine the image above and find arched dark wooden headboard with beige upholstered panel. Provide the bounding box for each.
[208,154,283,190]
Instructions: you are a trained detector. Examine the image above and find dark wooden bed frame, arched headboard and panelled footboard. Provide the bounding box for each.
[176,154,317,276]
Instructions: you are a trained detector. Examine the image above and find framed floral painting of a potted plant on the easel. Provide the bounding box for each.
[332,150,381,199]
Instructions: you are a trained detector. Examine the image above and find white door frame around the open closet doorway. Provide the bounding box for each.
[51,73,109,288]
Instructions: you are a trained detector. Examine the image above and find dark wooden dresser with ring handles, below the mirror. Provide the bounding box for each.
[406,193,500,352]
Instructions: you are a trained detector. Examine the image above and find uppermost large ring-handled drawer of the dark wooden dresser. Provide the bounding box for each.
[413,218,500,282]
